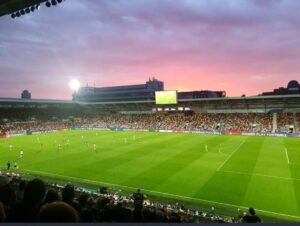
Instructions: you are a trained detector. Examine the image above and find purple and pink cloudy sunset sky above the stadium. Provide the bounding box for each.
[0,0,300,99]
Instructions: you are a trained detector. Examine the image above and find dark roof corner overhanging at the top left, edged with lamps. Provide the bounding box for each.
[0,0,46,17]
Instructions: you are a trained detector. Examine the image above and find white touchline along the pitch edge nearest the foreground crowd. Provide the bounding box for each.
[23,170,300,219]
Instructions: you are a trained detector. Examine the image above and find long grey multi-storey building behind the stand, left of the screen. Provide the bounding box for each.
[73,78,164,102]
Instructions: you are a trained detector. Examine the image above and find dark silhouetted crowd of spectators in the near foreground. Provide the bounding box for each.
[0,175,261,223]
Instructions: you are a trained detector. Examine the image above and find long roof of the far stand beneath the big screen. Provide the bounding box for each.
[0,95,300,113]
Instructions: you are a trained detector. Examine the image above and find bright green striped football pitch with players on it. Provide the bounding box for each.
[0,131,300,222]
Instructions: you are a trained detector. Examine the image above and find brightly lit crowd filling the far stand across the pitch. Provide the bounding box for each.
[0,113,294,134]
